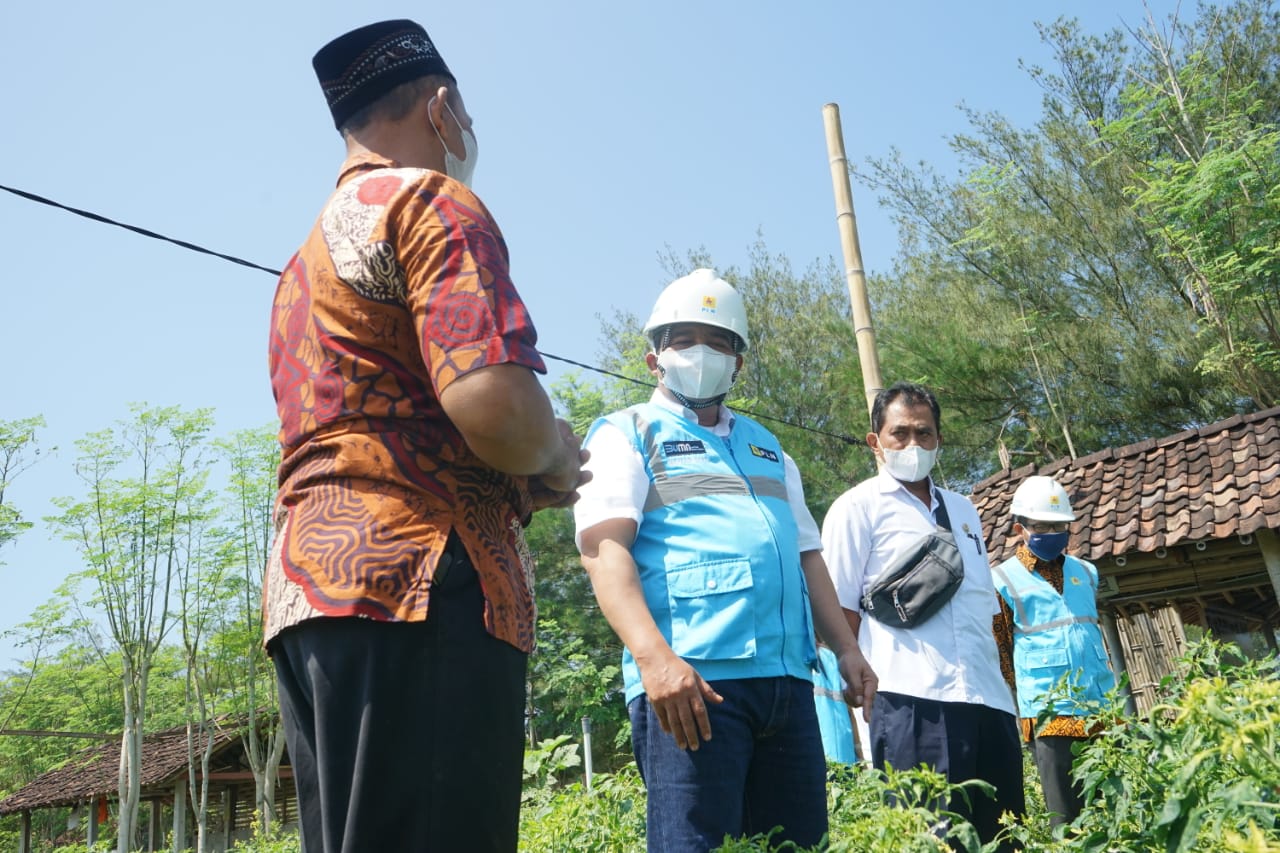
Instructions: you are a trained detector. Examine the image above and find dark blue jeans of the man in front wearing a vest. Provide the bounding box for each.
[627,678,827,853]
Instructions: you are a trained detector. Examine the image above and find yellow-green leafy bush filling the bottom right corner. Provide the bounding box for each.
[1069,640,1280,853]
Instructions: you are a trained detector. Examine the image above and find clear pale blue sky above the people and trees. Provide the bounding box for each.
[0,0,1192,670]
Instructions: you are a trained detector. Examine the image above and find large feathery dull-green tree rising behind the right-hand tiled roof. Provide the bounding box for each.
[859,0,1277,485]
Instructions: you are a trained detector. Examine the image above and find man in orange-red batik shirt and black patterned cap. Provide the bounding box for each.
[272,20,582,853]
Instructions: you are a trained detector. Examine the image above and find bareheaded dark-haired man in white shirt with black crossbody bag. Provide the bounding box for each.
[822,382,1025,844]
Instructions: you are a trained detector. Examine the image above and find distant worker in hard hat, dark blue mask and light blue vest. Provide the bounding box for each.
[992,476,1115,826]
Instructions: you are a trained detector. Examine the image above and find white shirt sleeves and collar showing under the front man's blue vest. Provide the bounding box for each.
[573,391,822,553]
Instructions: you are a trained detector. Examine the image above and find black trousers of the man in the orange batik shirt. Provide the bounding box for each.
[271,540,526,853]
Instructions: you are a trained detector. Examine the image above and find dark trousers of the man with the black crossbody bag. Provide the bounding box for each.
[870,693,1027,849]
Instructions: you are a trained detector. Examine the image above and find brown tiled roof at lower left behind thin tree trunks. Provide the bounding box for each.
[0,727,239,815]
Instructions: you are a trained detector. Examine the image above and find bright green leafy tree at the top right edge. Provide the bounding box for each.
[1101,1,1280,407]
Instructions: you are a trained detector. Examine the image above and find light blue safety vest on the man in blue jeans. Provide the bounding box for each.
[591,403,817,702]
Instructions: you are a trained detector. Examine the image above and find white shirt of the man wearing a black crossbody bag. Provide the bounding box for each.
[822,471,1014,713]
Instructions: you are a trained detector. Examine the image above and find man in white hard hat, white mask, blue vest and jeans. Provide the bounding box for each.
[573,269,876,853]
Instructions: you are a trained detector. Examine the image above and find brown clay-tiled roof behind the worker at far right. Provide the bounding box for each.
[973,407,1280,561]
